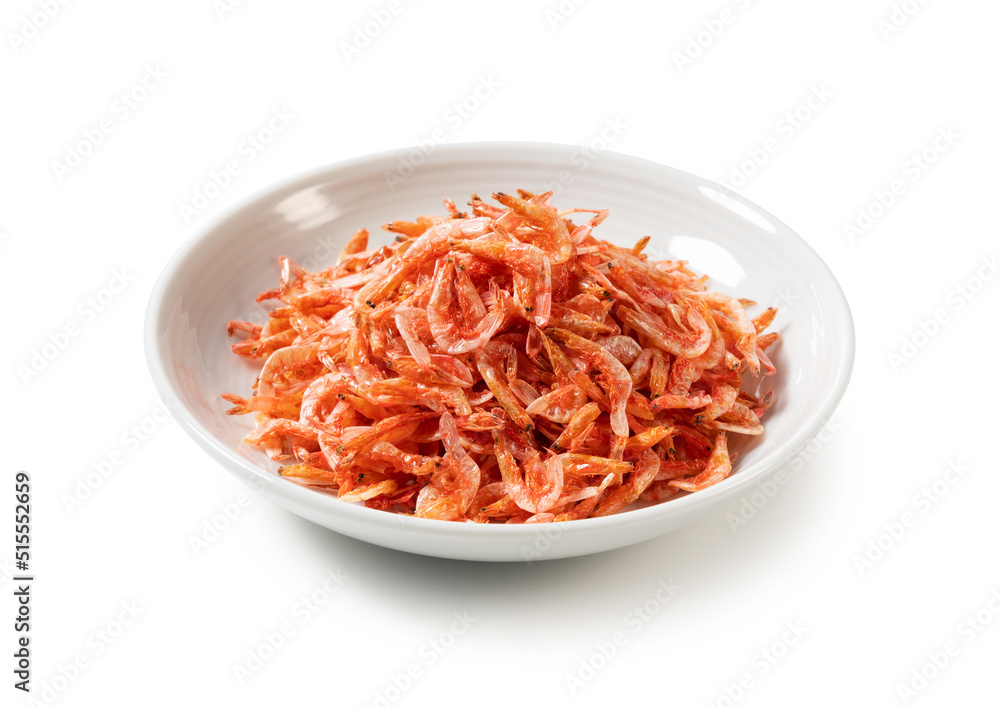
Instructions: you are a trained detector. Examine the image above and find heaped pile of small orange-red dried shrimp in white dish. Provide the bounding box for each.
[222,191,778,523]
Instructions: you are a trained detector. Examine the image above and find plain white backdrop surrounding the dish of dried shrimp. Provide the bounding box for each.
[0,0,1000,707]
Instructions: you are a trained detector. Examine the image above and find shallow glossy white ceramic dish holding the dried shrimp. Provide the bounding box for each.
[146,143,854,561]
